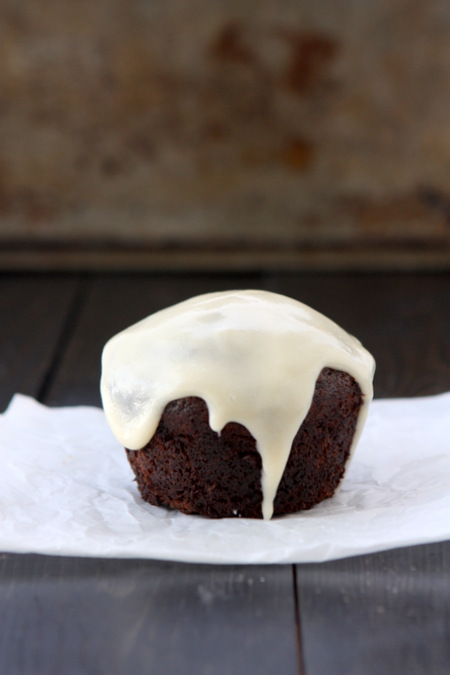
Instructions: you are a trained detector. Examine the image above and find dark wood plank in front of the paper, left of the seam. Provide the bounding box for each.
[0,556,298,675]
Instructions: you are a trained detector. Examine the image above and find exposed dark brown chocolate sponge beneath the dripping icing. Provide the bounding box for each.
[126,368,362,518]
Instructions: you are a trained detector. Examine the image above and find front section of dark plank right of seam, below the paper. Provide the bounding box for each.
[297,542,450,675]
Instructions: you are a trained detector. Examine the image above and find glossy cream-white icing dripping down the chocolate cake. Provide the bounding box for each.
[101,291,375,518]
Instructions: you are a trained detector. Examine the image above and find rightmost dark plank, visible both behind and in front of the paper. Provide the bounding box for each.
[269,274,450,675]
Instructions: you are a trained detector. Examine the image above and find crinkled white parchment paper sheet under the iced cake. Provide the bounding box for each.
[0,392,450,563]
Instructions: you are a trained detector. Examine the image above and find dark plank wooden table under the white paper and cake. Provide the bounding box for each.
[0,273,450,675]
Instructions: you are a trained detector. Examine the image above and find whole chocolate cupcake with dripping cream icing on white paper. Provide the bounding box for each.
[101,290,375,519]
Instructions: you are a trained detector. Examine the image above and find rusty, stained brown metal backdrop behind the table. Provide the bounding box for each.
[0,0,450,270]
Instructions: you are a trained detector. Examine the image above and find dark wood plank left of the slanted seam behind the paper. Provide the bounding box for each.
[0,274,80,410]
